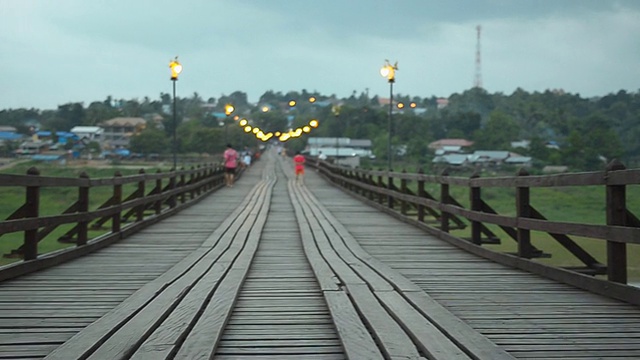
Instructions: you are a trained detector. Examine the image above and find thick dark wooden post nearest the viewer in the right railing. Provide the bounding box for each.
[607,160,627,284]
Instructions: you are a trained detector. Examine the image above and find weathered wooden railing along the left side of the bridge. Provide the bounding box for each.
[0,164,231,280]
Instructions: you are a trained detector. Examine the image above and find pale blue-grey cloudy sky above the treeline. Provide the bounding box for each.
[0,0,640,109]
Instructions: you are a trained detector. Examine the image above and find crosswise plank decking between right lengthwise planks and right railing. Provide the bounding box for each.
[306,170,640,360]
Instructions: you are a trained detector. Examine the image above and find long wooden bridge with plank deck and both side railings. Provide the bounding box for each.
[0,148,640,360]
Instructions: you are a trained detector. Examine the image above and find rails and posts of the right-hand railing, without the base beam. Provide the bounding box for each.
[311,161,640,284]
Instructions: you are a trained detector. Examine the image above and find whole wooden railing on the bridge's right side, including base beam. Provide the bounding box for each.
[308,159,640,304]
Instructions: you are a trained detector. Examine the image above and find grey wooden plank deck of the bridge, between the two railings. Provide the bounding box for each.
[0,148,640,360]
